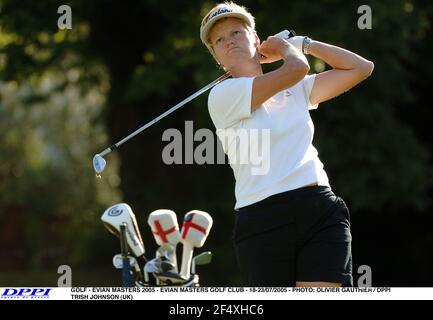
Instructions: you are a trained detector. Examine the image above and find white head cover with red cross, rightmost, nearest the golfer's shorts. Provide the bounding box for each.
[181,210,213,248]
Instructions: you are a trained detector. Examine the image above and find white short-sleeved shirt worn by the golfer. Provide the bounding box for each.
[208,74,329,210]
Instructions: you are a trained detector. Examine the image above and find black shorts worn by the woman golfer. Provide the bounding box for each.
[233,186,353,287]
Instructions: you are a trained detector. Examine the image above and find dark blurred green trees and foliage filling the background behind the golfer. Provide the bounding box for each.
[0,0,433,287]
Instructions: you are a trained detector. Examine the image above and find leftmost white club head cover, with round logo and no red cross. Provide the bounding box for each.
[101,203,145,257]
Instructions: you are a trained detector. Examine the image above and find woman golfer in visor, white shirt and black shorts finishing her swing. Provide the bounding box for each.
[200,2,374,287]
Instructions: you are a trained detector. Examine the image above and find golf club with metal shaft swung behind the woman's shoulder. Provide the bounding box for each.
[93,72,231,177]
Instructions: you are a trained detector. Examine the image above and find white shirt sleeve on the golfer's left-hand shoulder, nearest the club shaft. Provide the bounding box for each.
[208,78,254,129]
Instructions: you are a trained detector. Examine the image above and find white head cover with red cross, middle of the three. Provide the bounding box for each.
[147,209,180,246]
